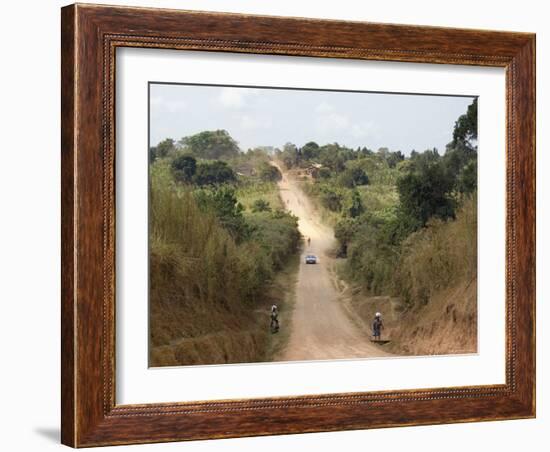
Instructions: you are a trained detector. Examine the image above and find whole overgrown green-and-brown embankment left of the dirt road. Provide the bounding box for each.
[150,149,300,366]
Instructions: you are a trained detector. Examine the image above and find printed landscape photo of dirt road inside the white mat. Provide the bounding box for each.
[149,82,478,367]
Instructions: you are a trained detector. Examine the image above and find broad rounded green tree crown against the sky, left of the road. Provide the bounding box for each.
[179,130,239,159]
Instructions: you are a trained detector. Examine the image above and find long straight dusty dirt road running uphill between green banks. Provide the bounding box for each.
[275,168,387,361]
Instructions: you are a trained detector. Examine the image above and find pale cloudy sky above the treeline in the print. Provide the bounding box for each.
[150,84,473,155]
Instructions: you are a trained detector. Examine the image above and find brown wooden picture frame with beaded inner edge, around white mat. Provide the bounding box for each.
[61,4,535,447]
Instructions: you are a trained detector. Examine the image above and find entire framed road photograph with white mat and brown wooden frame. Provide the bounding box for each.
[61,4,535,447]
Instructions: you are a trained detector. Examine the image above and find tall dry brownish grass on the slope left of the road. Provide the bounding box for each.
[149,170,300,367]
